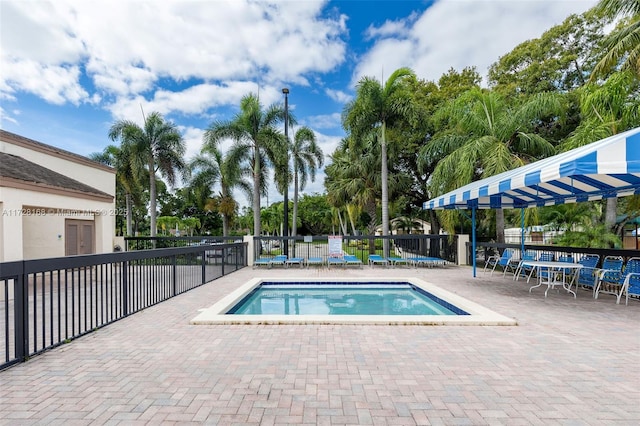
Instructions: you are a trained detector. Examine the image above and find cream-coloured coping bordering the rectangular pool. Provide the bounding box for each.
[189,277,518,326]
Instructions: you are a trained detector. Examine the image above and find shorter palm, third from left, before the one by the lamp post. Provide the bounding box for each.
[190,143,251,237]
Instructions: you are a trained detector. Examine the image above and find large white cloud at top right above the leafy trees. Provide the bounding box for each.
[352,0,597,84]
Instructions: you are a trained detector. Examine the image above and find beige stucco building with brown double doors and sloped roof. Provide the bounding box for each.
[0,130,117,262]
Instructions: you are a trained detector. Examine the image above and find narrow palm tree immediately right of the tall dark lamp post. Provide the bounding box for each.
[290,127,324,236]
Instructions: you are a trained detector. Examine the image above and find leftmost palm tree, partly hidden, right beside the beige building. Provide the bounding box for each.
[89,145,142,236]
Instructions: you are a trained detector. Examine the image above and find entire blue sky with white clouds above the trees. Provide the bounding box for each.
[0,0,596,205]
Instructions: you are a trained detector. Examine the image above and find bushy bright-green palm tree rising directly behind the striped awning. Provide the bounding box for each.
[418,89,560,242]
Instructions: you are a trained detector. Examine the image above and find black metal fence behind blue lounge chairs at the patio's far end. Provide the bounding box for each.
[253,234,458,263]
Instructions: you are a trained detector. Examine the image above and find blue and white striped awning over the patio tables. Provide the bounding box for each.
[423,127,640,210]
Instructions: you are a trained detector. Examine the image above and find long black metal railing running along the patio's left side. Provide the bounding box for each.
[0,243,247,370]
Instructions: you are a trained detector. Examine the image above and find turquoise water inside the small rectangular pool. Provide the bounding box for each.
[227,282,469,315]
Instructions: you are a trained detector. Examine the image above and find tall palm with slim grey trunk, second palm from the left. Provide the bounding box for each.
[109,112,186,237]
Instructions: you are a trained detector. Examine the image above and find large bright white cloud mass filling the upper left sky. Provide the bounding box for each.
[0,0,346,117]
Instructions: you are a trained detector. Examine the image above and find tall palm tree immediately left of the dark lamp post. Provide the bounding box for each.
[204,93,284,236]
